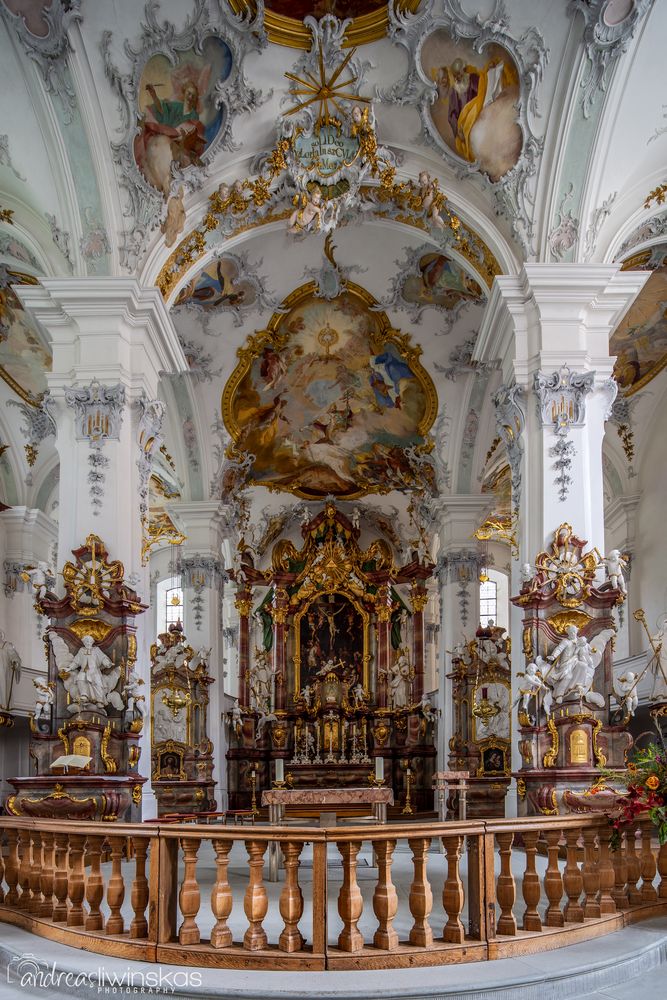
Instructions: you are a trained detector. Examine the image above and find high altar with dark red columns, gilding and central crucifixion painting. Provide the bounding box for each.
[227,502,436,812]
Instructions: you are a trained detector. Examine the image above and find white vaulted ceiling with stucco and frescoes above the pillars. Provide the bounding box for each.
[0,0,667,556]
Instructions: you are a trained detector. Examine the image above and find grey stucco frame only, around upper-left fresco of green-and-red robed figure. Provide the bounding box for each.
[100,0,266,271]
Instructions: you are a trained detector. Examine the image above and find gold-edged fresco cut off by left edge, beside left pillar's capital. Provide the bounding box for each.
[0,265,51,405]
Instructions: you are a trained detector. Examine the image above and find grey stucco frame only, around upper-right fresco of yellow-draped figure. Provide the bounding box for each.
[377,0,549,255]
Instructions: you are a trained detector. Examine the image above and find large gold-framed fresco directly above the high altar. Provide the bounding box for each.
[223,283,437,498]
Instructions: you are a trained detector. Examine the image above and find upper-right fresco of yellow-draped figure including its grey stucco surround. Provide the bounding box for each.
[378,0,549,252]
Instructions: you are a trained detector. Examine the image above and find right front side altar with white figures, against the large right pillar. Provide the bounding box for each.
[512,524,637,815]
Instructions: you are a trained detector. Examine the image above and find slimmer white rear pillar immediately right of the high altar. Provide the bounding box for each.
[436,495,491,771]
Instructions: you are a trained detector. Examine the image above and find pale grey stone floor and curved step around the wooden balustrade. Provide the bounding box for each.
[0,842,667,1000]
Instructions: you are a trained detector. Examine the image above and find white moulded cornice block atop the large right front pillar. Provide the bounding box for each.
[473,264,651,385]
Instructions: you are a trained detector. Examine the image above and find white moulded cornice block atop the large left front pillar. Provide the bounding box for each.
[20,277,188,397]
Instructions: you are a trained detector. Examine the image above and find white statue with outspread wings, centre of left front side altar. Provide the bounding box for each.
[50,632,124,714]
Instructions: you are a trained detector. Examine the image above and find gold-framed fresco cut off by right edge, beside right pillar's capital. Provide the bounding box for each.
[610,243,667,396]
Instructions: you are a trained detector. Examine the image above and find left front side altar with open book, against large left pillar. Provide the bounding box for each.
[5,535,147,822]
